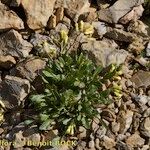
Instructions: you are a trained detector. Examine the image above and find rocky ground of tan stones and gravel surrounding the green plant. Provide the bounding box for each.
[0,0,150,150]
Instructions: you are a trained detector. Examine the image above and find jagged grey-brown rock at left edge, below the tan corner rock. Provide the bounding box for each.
[0,29,33,59]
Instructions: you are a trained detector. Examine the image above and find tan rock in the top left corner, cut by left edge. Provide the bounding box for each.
[0,2,24,31]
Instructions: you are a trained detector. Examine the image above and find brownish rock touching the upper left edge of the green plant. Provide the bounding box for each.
[11,58,46,81]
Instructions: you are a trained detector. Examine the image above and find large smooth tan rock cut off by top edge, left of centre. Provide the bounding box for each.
[21,0,56,30]
